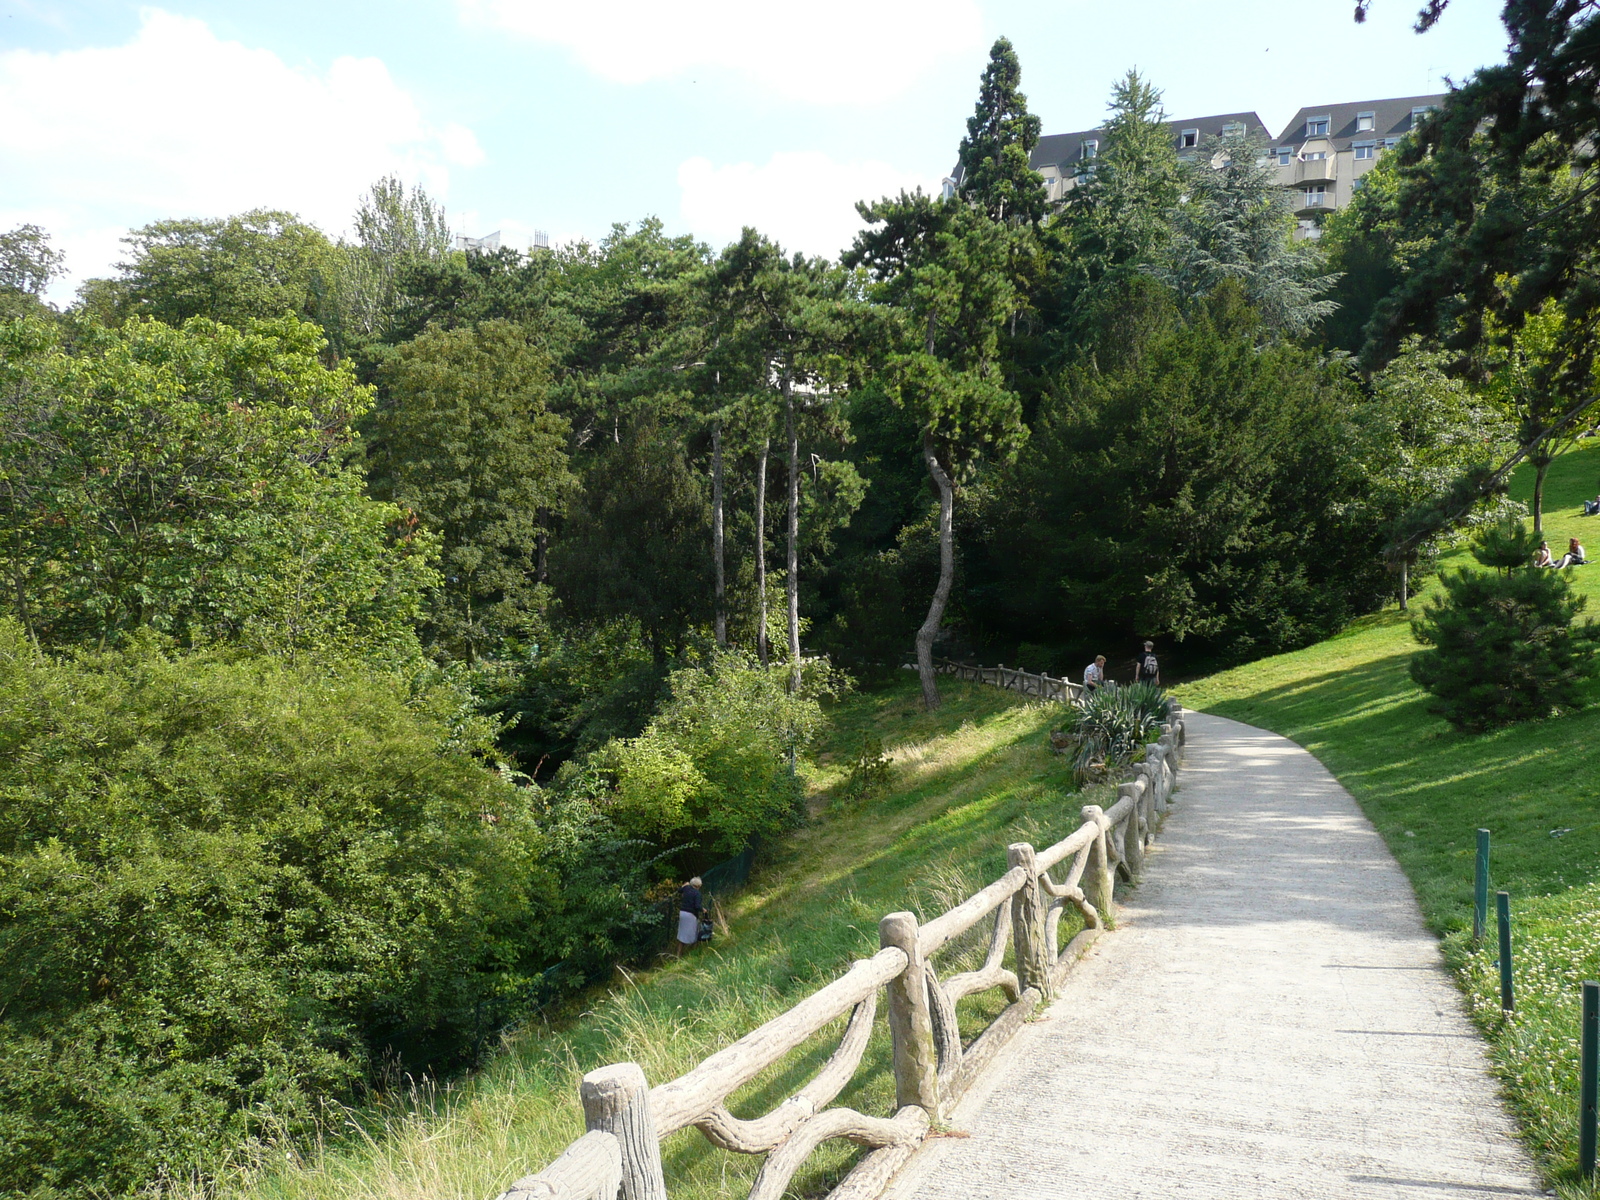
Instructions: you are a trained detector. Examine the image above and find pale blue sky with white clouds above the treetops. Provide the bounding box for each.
[0,0,1506,304]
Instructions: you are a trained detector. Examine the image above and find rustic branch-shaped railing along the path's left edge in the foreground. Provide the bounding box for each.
[501,704,1184,1200]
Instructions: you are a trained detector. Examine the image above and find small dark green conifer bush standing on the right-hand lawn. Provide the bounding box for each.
[1411,522,1600,731]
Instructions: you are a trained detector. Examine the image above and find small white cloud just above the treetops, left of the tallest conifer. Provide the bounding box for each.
[678,150,938,258]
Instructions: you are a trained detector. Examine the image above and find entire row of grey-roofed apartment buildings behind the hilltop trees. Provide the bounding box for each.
[944,94,1443,238]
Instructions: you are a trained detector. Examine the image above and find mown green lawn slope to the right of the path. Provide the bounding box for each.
[1178,442,1600,1197]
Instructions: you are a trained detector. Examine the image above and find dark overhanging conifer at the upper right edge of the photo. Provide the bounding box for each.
[1357,0,1600,555]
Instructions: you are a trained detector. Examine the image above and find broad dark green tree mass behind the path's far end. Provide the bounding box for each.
[971,280,1384,656]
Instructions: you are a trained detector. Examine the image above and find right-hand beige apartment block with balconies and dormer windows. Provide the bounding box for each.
[1270,94,1445,237]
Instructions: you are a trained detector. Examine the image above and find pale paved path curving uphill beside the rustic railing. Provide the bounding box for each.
[888,714,1544,1200]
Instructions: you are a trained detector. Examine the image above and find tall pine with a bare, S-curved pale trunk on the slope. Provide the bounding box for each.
[846,192,1026,710]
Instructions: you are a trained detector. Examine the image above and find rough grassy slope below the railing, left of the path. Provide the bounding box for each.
[219,680,1083,1200]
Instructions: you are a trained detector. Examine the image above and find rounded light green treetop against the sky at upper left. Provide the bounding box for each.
[105,208,339,328]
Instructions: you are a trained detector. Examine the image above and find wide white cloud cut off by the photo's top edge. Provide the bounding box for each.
[458,0,982,104]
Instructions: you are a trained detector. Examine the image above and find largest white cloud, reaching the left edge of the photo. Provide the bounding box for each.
[0,8,485,294]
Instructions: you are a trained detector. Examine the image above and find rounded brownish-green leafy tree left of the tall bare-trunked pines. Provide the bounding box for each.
[371,320,576,662]
